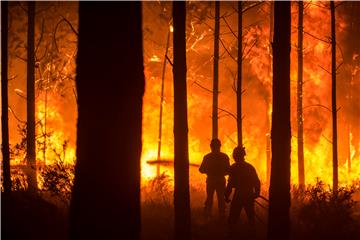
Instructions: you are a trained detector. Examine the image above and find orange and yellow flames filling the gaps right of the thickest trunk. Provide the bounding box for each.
[142,0,360,187]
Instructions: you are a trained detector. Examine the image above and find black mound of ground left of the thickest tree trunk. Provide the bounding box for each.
[1,191,68,240]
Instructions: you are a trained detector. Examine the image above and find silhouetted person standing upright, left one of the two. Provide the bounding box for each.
[199,139,230,217]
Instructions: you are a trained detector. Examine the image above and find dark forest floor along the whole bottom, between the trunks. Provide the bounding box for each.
[1,188,360,240]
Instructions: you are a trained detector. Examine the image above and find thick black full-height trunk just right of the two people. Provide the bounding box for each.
[267,2,291,240]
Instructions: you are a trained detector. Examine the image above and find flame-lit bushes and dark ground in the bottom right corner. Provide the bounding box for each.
[291,179,360,239]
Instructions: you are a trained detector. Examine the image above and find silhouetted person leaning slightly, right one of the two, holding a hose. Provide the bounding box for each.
[225,147,260,230]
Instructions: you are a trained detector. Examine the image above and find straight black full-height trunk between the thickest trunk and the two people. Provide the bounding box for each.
[173,2,191,240]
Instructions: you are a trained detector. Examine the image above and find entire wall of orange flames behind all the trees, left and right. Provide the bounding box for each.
[3,2,360,189]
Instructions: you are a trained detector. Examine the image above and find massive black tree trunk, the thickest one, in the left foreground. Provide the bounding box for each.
[70,2,145,239]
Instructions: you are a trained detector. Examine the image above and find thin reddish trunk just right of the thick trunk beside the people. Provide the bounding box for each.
[297,0,305,188]
